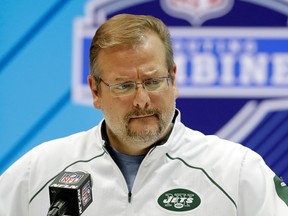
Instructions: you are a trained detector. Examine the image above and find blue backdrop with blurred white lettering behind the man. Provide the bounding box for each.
[0,0,288,181]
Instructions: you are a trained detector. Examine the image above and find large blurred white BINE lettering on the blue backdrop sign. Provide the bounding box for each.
[174,48,288,86]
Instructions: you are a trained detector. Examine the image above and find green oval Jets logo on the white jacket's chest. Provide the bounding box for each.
[158,188,201,212]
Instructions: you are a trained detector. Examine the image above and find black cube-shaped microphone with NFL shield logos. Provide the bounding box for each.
[47,171,93,216]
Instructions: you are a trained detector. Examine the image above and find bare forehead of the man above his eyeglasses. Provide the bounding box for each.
[98,34,167,76]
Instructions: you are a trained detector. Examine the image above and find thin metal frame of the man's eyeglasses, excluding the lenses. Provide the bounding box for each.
[98,74,171,97]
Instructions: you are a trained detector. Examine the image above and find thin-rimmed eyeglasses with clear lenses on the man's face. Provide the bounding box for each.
[100,76,170,97]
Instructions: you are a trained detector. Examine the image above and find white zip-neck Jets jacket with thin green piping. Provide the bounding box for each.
[0,110,288,216]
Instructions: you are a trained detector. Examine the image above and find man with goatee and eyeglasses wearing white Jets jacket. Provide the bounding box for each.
[0,14,288,216]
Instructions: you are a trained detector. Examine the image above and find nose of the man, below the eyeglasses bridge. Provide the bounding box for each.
[133,83,150,109]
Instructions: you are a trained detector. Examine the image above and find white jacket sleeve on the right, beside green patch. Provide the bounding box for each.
[237,150,288,216]
